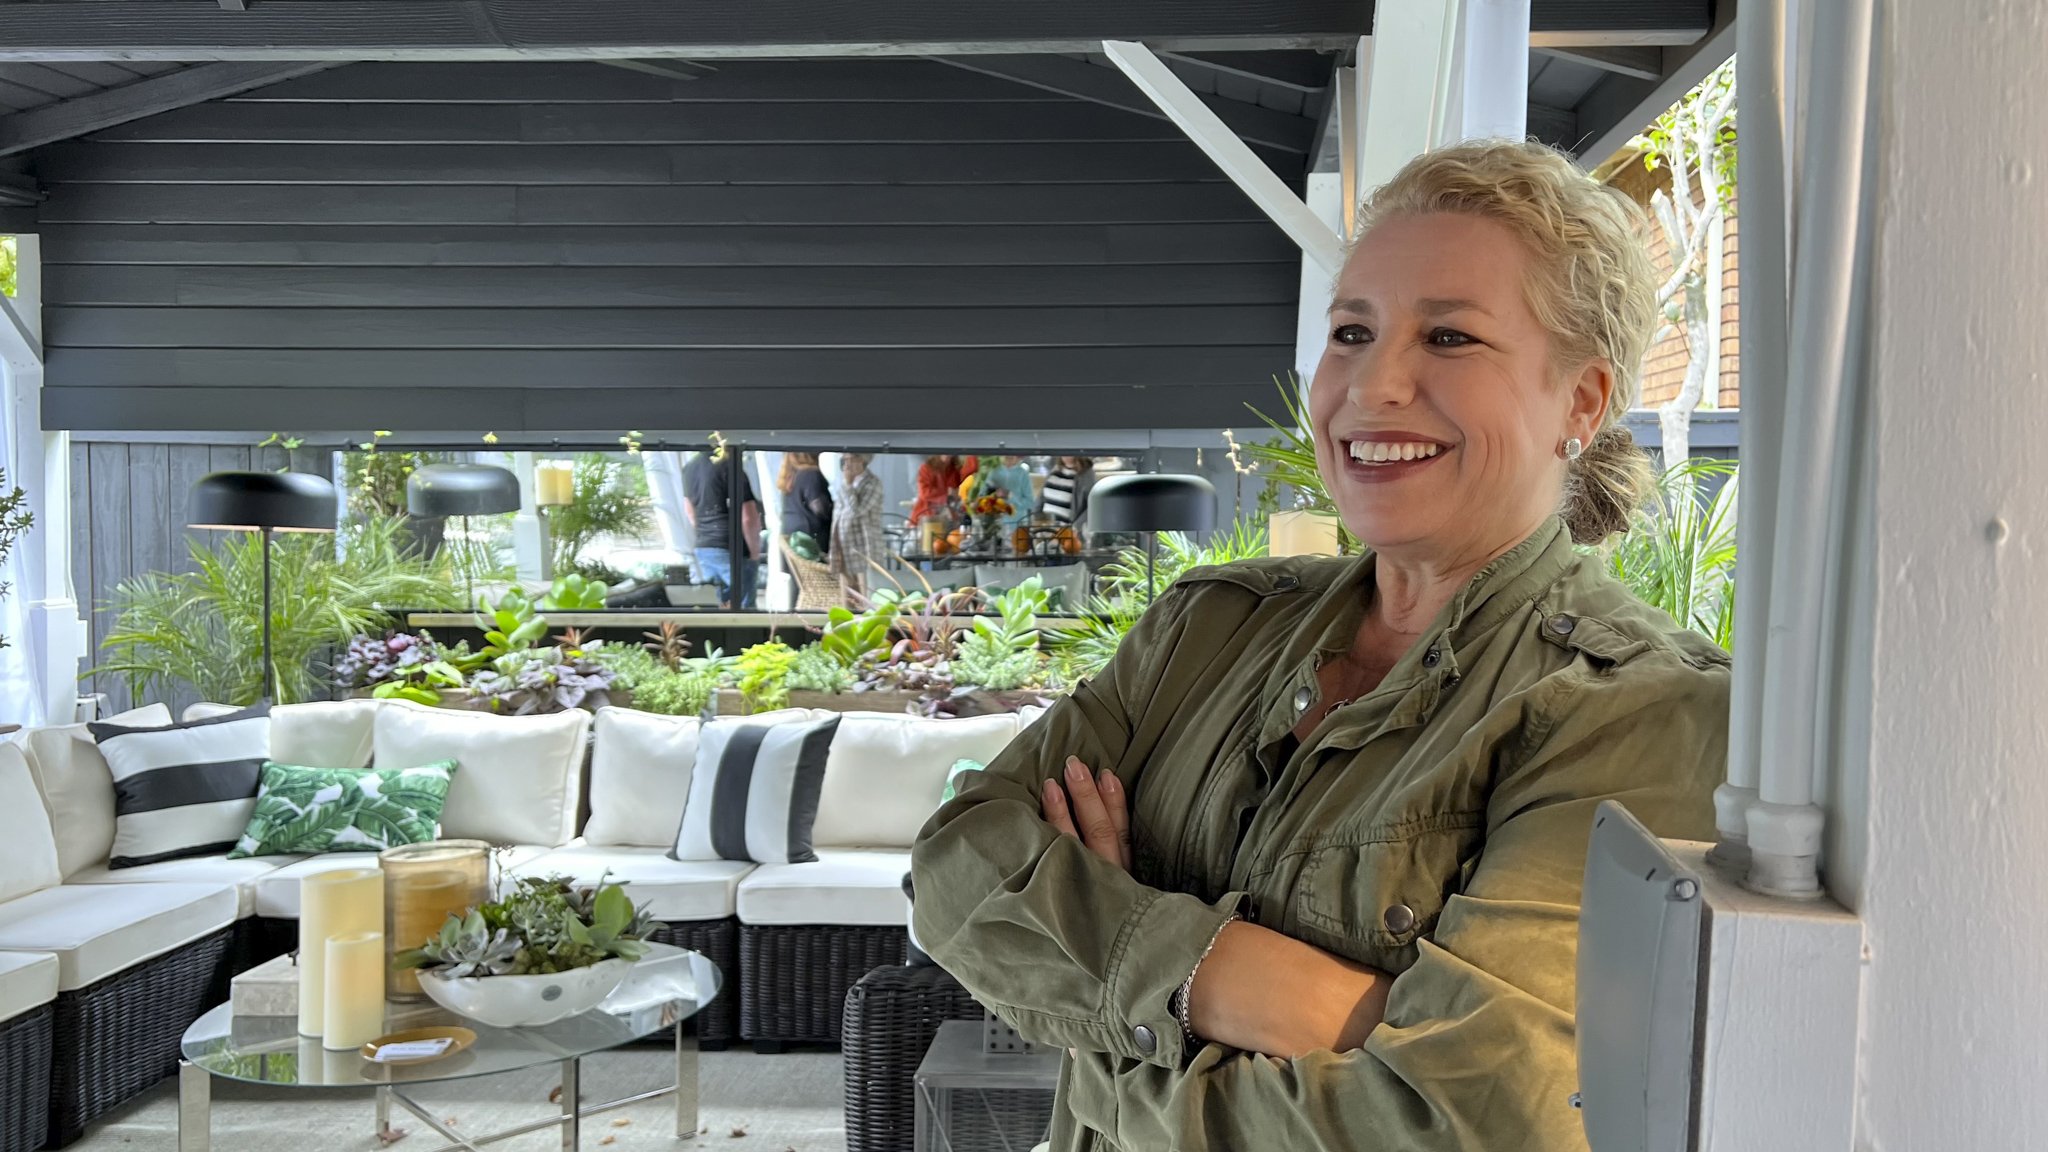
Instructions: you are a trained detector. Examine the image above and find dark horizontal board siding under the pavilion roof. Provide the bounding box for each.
[35,59,1300,435]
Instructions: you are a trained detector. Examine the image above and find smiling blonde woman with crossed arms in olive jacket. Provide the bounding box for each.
[913,141,1729,1152]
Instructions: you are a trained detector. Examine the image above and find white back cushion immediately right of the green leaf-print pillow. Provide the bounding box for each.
[373,701,590,847]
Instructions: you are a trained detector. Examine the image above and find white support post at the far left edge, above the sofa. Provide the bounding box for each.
[0,236,90,724]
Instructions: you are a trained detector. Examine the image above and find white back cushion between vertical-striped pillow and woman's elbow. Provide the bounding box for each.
[811,711,1018,851]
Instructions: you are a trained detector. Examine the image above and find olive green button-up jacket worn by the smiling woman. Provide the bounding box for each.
[913,519,1729,1152]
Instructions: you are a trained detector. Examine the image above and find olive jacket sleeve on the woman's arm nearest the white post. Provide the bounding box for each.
[1071,658,1729,1152]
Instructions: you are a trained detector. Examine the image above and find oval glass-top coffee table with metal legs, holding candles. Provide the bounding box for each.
[178,945,721,1152]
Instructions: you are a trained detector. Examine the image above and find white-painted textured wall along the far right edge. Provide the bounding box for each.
[1839,0,2048,1152]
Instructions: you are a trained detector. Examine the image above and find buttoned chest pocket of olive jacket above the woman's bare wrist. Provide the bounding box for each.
[1288,812,1483,974]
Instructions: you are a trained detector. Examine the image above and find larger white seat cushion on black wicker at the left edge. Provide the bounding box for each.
[0,883,236,992]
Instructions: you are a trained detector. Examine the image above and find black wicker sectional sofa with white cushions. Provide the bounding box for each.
[0,699,1028,1152]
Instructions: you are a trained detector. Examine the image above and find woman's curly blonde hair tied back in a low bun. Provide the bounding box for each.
[1354,139,1657,543]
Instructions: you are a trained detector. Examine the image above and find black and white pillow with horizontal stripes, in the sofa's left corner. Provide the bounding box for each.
[90,703,270,867]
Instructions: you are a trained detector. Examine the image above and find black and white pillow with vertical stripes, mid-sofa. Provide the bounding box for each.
[670,715,840,863]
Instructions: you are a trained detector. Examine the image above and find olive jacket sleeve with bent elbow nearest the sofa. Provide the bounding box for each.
[911,588,1239,1068]
